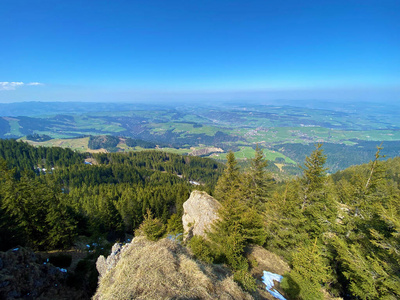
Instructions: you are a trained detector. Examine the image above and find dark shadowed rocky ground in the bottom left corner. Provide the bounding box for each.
[0,247,85,299]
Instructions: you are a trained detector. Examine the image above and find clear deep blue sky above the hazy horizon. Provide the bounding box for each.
[0,0,400,102]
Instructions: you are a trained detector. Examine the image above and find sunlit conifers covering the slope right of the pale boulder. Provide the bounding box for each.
[190,144,400,300]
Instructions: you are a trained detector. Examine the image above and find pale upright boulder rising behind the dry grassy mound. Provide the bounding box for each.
[182,191,221,240]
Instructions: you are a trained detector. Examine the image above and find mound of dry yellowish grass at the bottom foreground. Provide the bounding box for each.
[94,237,252,300]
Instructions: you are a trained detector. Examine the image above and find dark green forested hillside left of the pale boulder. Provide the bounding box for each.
[0,140,223,250]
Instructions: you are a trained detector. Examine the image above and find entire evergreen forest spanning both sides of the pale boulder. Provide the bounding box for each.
[0,140,400,299]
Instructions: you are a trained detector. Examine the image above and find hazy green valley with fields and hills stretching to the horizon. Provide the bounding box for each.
[0,101,400,175]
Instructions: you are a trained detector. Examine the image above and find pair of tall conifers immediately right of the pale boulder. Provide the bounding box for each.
[208,152,266,290]
